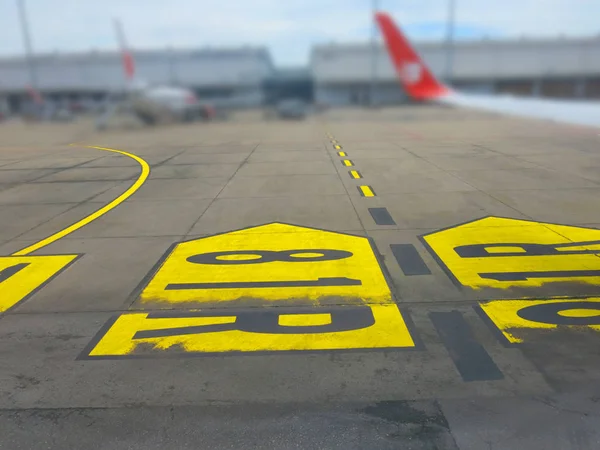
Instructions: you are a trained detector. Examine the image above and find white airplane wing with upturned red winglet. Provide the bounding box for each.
[375,12,600,127]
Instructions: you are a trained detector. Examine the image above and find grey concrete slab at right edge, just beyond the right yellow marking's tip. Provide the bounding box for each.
[490,189,600,224]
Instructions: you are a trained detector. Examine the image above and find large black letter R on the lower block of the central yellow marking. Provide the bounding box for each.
[133,306,375,339]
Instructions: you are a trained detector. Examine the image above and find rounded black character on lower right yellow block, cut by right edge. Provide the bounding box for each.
[517,302,600,326]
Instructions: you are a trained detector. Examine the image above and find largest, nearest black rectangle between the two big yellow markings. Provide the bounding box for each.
[429,311,504,381]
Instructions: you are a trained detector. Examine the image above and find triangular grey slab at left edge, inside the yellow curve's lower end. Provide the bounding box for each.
[0,203,76,246]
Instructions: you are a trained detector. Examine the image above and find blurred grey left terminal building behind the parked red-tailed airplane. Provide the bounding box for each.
[0,47,274,110]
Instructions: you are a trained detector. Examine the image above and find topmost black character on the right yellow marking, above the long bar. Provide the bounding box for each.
[454,241,600,258]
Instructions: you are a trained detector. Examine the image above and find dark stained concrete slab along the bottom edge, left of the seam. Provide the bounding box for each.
[0,401,457,450]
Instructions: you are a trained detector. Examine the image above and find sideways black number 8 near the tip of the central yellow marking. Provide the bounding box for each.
[187,249,352,264]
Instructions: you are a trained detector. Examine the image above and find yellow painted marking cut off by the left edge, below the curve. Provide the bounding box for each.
[0,255,79,312]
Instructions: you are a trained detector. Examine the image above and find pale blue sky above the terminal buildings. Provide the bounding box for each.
[0,0,600,66]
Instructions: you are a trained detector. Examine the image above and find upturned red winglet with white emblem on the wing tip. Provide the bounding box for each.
[375,12,450,100]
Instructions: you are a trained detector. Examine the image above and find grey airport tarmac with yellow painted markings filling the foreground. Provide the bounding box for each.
[0,106,600,450]
